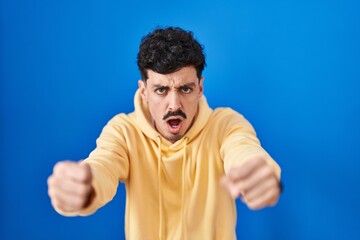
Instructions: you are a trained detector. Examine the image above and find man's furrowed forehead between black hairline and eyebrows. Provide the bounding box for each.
[147,67,198,86]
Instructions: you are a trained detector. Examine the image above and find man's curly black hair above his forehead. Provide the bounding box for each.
[137,27,206,82]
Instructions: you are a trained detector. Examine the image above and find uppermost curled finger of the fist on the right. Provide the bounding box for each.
[228,157,266,181]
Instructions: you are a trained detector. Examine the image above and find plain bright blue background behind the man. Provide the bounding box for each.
[0,0,360,240]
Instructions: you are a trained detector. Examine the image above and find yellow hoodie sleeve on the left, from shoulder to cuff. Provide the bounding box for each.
[61,115,129,216]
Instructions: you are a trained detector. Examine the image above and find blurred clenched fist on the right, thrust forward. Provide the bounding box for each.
[221,157,281,210]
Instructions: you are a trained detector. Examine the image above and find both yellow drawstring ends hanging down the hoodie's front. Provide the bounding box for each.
[157,136,189,240]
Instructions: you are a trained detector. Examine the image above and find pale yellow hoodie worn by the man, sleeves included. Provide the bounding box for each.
[58,91,280,240]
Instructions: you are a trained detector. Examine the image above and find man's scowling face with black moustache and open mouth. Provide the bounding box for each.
[139,67,204,143]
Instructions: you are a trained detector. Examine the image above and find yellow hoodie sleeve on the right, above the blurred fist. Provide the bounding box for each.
[220,109,281,180]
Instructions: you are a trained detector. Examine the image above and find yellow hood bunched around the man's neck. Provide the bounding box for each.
[130,89,212,147]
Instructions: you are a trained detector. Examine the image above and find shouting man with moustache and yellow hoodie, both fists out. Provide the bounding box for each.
[48,27,280,239]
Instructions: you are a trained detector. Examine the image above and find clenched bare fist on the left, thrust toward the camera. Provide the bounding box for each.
[47,161,94,212]
